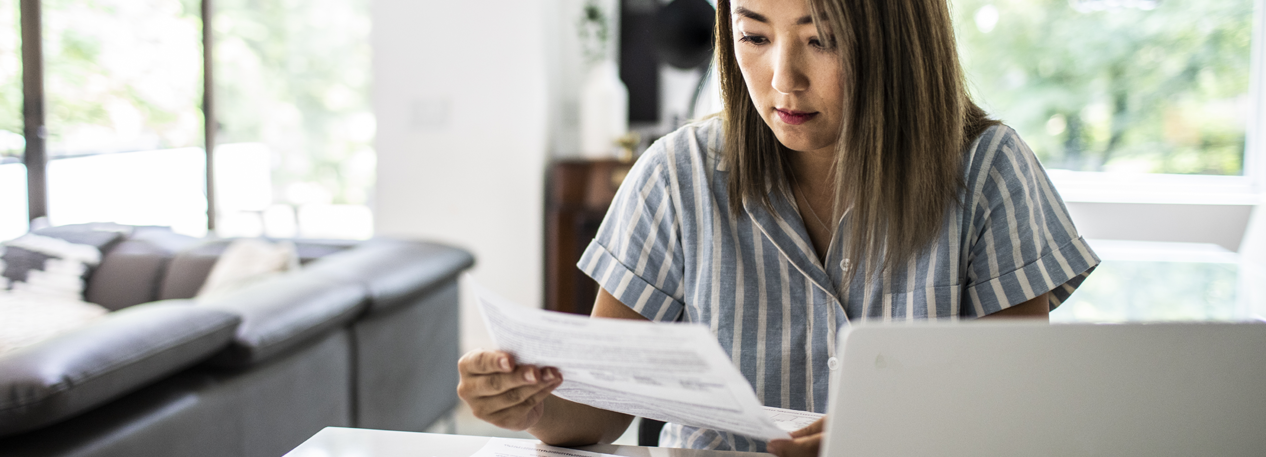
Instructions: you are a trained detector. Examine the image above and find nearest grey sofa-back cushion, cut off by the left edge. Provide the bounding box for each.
[0,300,239,437]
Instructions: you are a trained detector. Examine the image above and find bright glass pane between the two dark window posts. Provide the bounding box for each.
[43,0,206,234]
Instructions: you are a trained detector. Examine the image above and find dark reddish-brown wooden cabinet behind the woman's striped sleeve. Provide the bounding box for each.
[544,160,632,314]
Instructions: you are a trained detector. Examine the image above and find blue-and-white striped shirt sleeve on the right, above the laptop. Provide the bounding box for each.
[962,128,1099,318]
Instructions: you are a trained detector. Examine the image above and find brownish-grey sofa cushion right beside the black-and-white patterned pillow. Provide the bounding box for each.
[84,227,197,310]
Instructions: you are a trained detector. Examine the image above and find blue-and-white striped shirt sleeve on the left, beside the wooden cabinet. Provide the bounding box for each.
[576,144,685,322]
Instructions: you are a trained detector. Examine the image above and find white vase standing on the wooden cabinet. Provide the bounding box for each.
[580,59,629,158]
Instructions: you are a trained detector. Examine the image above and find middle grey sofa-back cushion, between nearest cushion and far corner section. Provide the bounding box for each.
[199,270,366,368]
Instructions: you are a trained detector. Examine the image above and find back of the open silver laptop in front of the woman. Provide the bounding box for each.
[822,323,1266,457]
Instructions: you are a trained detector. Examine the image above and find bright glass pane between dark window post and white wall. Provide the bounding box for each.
[213,0,375,238]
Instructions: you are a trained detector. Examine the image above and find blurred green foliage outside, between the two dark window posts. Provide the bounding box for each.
[42,0,203,158]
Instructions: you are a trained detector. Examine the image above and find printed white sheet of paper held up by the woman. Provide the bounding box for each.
[471,281,790,441]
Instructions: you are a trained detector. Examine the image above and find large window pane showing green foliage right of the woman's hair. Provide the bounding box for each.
[951,0,1253,175]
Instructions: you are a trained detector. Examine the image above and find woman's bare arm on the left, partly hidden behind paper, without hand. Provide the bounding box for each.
[528,287,647,446]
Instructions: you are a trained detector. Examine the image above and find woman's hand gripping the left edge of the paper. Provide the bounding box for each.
[457,349,562,430]
